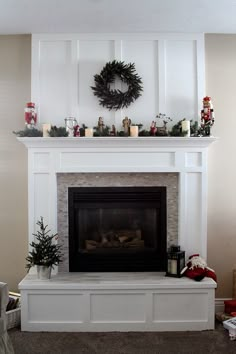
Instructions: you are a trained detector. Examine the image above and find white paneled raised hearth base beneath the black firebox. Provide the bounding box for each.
[19,273,216,332]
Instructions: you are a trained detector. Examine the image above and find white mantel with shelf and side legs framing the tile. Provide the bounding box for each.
[18,137,216,258]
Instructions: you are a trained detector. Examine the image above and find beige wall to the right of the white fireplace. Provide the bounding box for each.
[205,35,236,297]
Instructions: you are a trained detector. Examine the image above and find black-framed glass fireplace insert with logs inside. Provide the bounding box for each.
[68,187,166,272]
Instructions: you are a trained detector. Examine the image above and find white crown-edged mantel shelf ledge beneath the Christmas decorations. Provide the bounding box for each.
[17,137,217,149]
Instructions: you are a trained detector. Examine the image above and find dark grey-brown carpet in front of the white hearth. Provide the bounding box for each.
[8,323,236,354]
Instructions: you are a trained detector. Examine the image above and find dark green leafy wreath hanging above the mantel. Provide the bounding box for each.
[91,60,143,110]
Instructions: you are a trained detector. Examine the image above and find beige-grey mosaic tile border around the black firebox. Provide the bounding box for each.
[57,173,178,272]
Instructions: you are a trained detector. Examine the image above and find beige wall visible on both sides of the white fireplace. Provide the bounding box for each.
[0,35,236,297]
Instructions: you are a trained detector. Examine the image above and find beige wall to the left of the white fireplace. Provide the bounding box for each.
[0,35,31,290]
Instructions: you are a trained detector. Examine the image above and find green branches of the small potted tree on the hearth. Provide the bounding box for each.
[26,217,62,270]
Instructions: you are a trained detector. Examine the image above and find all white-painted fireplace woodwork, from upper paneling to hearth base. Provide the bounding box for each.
[18,34,216,331]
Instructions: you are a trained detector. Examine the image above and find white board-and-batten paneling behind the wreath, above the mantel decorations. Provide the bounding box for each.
[31,34,205,129]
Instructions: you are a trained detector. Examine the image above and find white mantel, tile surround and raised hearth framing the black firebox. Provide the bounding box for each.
[18,137,216,331]
